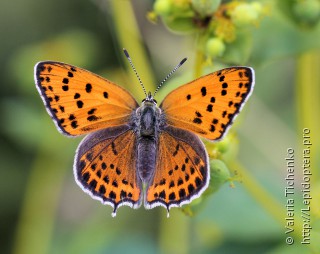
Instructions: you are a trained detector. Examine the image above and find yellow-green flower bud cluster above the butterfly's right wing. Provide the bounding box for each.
[149,0,266,64]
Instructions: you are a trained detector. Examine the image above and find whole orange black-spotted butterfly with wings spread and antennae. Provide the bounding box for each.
[34,49,254,216]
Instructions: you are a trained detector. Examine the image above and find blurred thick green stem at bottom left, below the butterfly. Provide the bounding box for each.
[13,146,68,254]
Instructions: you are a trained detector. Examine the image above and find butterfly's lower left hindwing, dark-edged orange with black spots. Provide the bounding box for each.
[74,125,142,216]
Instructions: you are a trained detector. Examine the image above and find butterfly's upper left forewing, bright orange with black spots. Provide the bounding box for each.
[35,61,138,136]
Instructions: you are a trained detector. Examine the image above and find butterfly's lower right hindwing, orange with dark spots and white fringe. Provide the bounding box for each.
[145,126,210,211]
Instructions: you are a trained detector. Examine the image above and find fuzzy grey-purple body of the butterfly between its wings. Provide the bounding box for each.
[135,100,161,183]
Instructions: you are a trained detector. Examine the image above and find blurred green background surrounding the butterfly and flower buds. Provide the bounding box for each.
[0,0,320,254]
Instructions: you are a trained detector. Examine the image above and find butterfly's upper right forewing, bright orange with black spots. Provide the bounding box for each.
[160,67,254,140]
